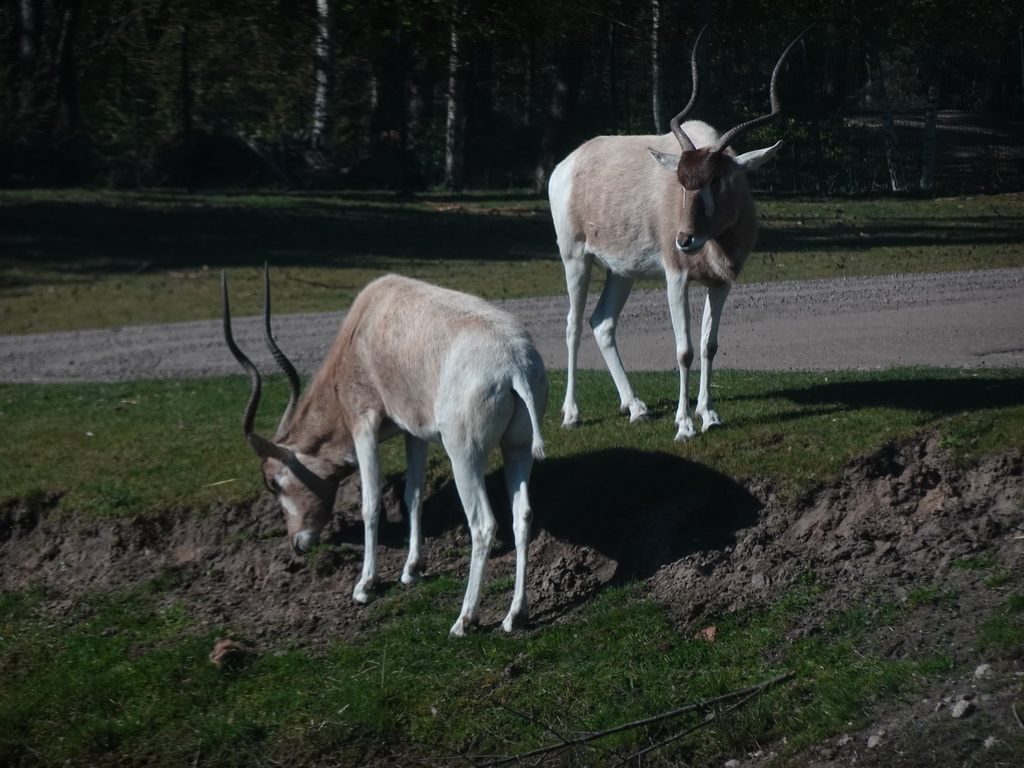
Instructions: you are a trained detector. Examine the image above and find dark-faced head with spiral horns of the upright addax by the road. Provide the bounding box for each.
[649,27,806,253]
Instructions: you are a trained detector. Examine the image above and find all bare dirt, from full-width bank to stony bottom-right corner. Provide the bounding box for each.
[0,434,1024,767]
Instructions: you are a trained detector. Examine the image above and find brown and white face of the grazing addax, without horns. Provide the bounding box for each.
[263,454,352,554]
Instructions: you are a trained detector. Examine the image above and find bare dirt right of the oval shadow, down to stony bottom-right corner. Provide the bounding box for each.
[650,434,1024,768]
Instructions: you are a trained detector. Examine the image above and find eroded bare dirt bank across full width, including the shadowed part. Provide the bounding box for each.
[0,435,1024,645]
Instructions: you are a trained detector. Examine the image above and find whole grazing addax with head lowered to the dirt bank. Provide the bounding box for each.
[222,274,548,636]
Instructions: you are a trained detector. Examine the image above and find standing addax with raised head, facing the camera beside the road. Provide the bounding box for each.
[548,30,800,440]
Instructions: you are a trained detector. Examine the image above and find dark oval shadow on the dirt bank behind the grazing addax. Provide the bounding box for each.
[407,449,763,584]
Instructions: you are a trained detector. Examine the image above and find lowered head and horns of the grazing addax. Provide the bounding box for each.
[221,269,351,554]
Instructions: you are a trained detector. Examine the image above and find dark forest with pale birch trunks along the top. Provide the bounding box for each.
[0,0,1024,194]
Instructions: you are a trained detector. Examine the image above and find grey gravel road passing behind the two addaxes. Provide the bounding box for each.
[0,267,1024,382]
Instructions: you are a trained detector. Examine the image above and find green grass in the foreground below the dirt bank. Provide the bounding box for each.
[0,579,950,766]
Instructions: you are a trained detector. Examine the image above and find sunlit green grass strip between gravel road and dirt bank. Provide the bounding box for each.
[0,369,1024,515]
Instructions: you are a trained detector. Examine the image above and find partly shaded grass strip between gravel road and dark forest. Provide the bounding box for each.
[0,190,1024,334]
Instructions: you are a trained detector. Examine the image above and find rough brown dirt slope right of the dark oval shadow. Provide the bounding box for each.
[651,434,1024,623]
